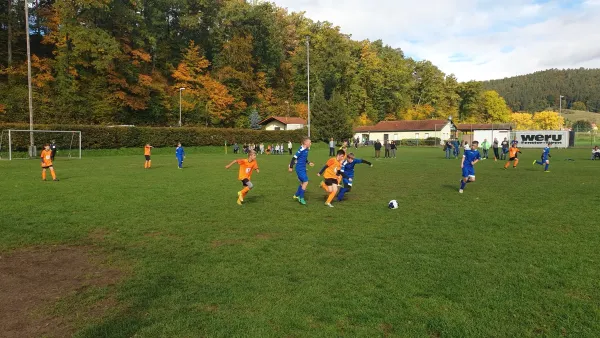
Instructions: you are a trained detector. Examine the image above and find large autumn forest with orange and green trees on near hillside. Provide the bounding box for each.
[0,0,544,139]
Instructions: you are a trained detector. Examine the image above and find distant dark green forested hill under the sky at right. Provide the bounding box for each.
[483,68,600,112]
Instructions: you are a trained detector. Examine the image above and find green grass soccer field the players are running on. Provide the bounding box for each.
[0,147,600,337]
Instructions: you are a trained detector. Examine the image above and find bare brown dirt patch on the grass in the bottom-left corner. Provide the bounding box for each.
[0,246,123,338]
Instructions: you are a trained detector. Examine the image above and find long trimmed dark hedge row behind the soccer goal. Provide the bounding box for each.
[0,124,305,150]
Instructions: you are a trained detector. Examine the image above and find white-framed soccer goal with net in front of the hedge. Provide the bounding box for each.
[0,129,81,160]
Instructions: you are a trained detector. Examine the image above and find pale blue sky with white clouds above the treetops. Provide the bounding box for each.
[273,0,600,81]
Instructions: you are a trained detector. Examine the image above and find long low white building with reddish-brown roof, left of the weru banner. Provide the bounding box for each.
[354,120,453,142]
